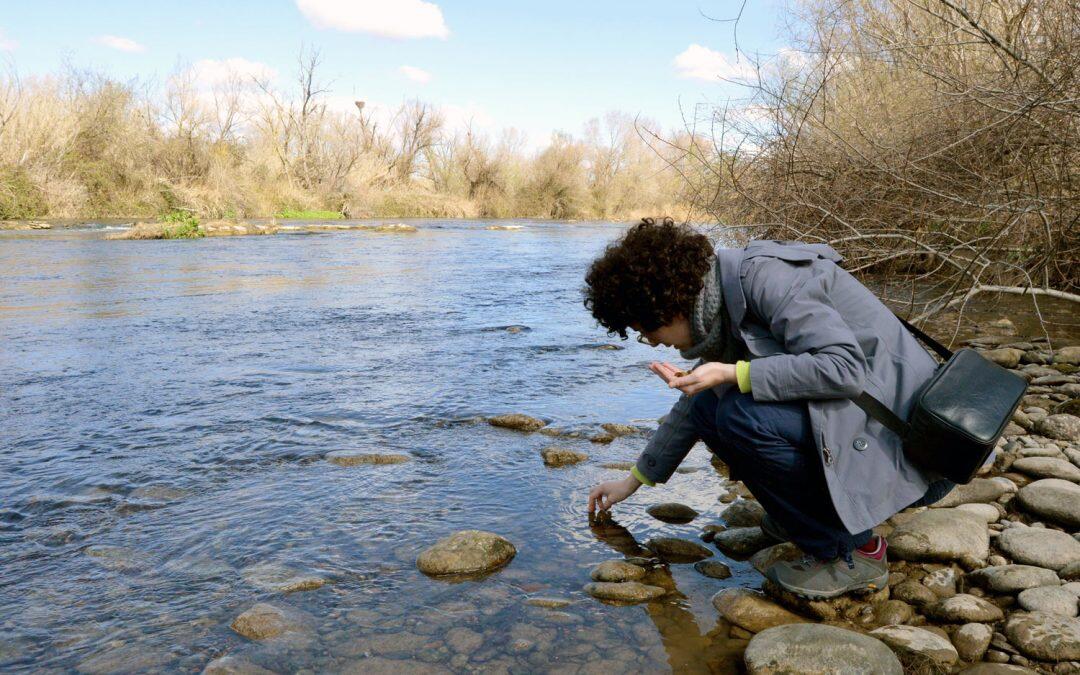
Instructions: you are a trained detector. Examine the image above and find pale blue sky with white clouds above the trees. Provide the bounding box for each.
[0,0,784,144]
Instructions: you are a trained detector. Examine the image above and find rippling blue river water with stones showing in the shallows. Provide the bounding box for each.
[0,220,1075,672]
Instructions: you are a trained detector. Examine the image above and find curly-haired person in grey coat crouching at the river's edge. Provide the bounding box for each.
[584,218,951,597]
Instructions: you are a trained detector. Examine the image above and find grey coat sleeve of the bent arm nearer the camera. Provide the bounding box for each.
[743,258,866,401]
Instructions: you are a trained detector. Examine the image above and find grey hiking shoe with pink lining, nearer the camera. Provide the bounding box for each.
[765,537,889,599]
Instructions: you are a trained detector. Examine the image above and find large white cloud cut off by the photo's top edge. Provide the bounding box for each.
[296,0,450,39]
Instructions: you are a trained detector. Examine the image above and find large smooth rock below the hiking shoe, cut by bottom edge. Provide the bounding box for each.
[744,623,904,675]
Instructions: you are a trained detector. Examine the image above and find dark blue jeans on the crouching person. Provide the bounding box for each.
[690,387,872,561]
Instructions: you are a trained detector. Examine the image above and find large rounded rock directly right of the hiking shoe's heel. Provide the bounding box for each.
[888,509,989,563]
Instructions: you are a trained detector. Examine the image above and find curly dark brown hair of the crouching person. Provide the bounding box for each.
[583,218,713,339]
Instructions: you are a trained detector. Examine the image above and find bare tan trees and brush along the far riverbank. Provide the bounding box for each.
[0,52,686,219]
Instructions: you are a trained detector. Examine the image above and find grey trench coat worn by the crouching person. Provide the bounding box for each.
[637,241,941,532]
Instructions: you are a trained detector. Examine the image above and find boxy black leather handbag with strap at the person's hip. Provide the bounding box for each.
[854,316,1027,483]
